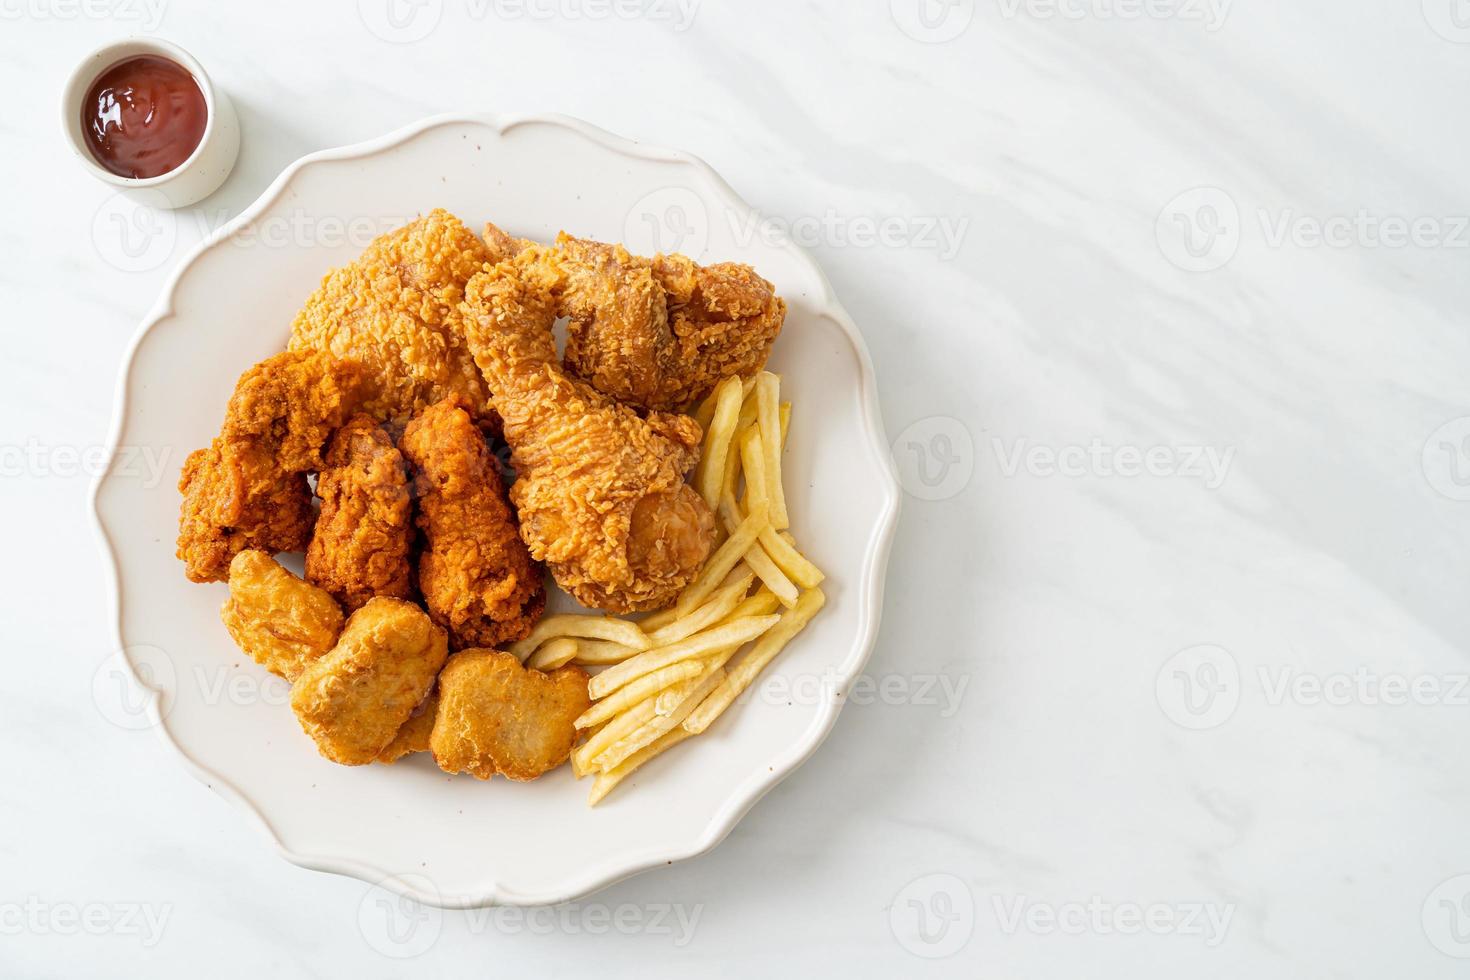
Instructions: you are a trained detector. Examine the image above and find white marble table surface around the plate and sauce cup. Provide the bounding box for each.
[0,0,1470,979]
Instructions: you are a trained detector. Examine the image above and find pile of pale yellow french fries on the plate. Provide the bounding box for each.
[510,372,826,805]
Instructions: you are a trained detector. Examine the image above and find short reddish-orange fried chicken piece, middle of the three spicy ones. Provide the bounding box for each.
[306,414,413,610]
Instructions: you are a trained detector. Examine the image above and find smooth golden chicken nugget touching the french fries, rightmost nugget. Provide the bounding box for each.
[429,649,591,782]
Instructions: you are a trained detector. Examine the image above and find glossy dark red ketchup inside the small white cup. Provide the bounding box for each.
[82,54,209,178]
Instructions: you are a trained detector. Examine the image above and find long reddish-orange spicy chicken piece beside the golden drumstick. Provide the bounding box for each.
[400,398,547,649]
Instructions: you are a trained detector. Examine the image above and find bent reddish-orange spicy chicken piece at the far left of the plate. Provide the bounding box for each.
[176,351,366,582]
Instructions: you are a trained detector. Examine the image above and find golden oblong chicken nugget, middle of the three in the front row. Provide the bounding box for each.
[291,598,448,765]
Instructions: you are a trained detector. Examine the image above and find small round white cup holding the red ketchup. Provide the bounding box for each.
[62,37,240,207]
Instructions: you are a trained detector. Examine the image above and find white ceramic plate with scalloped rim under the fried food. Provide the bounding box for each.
[94,116,900,907]
